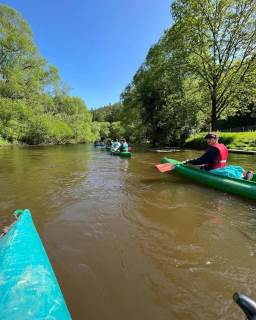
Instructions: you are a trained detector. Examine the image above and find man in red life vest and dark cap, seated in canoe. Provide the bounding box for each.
[185,132,228,171]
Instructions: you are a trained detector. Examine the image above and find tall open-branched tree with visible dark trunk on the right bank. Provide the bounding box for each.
[170,0,256,129]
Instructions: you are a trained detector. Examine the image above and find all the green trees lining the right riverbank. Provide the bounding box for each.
[93,0,256,144]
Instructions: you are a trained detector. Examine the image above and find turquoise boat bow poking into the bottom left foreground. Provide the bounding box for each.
[0,209,71,320]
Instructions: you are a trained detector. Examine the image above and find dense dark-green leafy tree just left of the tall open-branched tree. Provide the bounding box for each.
[122,33,201,145]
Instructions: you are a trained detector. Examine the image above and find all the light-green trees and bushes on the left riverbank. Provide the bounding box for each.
[0,5,99,144]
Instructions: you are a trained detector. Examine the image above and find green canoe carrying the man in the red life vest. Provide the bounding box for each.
[161,158,256,200]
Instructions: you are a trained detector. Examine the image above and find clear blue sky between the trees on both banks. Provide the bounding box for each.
[2,0,171,108]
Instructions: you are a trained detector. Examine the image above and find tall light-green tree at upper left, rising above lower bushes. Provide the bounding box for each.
[0,5,59,107]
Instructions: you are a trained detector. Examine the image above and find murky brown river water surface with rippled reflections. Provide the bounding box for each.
[0,145,256,320]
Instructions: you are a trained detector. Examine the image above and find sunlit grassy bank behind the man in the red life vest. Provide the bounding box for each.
[184,132,256,151]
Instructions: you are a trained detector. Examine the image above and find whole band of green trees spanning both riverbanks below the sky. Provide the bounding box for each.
[0,0,256,145]
